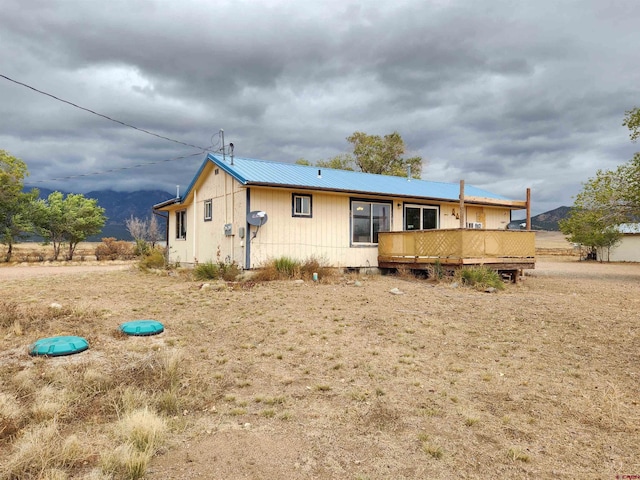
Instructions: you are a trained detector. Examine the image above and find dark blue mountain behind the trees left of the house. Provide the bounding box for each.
[33,188,175,241]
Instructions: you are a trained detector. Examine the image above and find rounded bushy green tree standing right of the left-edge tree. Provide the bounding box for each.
[34,192,106,260]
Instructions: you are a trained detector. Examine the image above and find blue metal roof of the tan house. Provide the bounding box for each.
[182,153,509,201]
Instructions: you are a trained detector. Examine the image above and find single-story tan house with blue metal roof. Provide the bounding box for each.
[154,154,529,269]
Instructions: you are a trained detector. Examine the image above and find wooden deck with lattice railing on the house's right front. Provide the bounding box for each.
[378,229,536,276]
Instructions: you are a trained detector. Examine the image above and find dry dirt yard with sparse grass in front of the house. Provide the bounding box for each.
[0,246,640,480]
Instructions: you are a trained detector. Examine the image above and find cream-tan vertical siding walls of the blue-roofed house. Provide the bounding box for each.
[164,169,509,268]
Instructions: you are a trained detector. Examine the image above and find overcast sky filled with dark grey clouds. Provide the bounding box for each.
[0,0,640,214]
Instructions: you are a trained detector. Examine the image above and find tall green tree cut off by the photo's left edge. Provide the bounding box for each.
[0,150,38,262]
